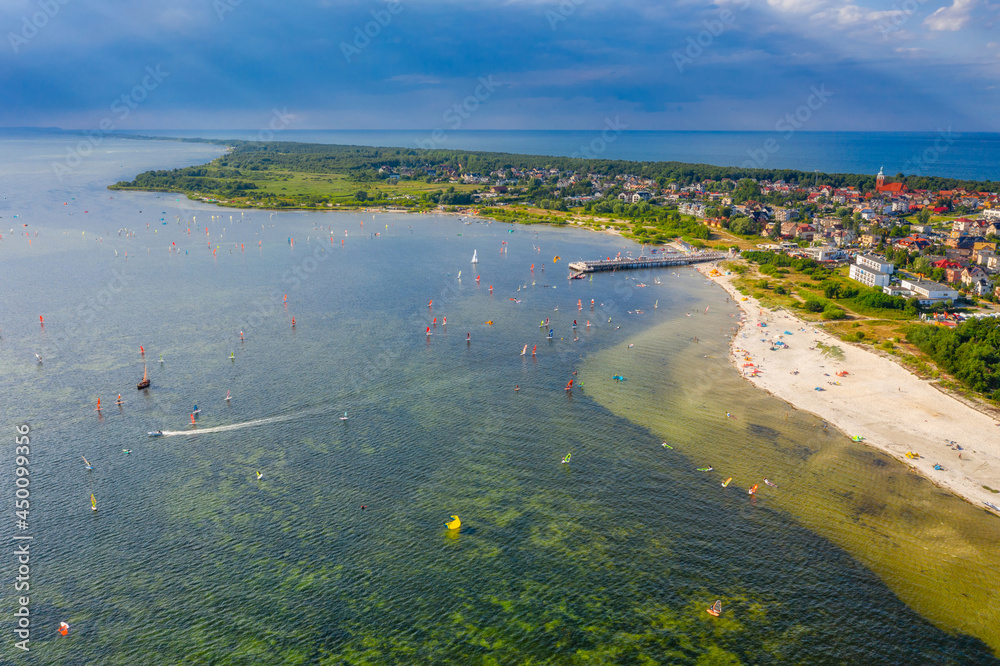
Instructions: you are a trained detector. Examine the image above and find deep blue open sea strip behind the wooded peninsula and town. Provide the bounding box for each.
[101,128,1000,181]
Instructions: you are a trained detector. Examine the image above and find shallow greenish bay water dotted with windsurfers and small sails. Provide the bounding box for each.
[0,134,1000,664]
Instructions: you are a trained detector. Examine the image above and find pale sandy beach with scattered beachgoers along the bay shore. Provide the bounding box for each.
[698,264,1000,515]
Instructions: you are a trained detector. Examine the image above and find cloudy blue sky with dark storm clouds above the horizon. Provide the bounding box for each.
[0,0,1000,132]
